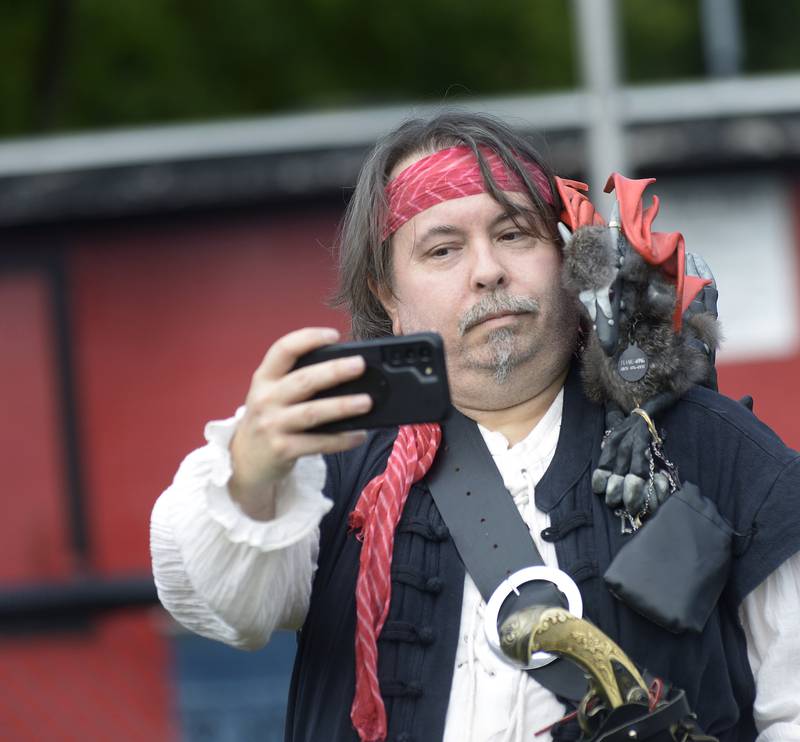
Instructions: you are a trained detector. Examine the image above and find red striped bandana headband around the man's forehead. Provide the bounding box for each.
[382,146,553,240]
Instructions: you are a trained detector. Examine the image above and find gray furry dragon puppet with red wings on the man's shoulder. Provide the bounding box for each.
[556,173,719,531]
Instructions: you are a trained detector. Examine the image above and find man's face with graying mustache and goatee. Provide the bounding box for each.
[383,186,577,404]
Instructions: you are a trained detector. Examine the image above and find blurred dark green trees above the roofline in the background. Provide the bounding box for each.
[0,0,800,136]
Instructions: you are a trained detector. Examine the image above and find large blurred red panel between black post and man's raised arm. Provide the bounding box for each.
[71,209,345,572]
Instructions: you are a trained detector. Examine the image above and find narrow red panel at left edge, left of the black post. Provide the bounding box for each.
[0,272,72,586]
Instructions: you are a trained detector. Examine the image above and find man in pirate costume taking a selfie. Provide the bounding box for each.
[152,114,800,742]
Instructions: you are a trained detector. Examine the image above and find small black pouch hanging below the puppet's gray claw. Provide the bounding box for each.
[603,482,734,634]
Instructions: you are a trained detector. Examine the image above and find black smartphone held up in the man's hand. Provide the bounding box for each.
[294,332,450,433]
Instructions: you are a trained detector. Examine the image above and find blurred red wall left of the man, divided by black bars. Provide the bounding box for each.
[0,206,346,742]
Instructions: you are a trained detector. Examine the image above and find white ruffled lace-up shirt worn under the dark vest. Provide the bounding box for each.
[151,393,800,742]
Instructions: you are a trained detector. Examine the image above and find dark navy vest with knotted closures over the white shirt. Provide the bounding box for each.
[285,372,800,742]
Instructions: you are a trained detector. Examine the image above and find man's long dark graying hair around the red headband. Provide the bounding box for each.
[333,111,560,340]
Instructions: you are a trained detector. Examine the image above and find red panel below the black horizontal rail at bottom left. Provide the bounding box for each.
[0,612,178,742]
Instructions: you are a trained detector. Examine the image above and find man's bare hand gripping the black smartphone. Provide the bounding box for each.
[228,327,372,520]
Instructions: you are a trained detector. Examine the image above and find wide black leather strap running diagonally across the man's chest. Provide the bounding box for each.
[426,410,587,701]
